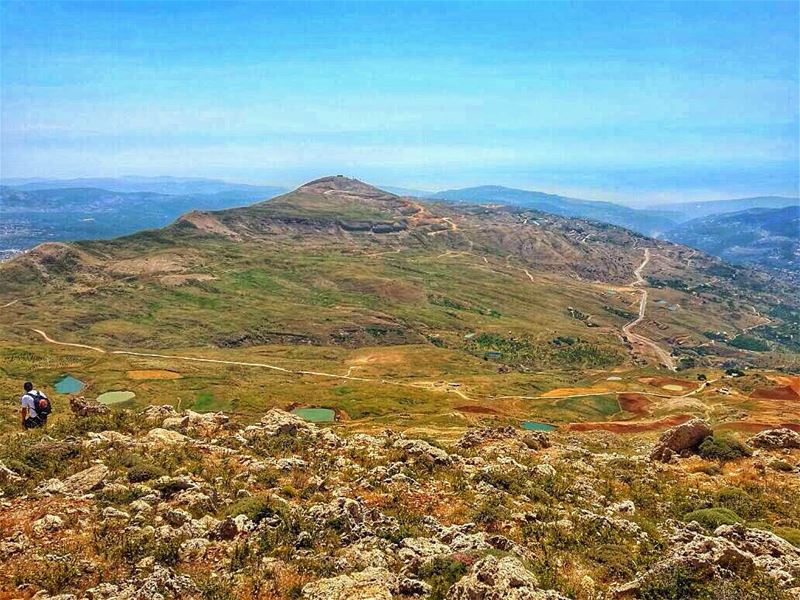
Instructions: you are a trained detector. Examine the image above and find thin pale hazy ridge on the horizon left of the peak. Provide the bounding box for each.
[2,175,286,200]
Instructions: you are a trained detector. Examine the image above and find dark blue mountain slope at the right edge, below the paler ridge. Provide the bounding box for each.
[664,205,800,278]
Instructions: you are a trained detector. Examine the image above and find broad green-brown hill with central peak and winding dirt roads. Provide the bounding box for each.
[0,177,798,435]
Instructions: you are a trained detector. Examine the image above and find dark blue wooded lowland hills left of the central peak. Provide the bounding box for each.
[0,186,288,258]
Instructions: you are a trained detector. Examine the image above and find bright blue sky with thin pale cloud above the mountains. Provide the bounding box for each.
[0,0,800,204]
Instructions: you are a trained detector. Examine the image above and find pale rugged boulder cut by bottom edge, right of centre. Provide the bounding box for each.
[447,555,565,600]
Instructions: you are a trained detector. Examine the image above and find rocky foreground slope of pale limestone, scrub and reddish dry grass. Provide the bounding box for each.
[0,403,800,600]
